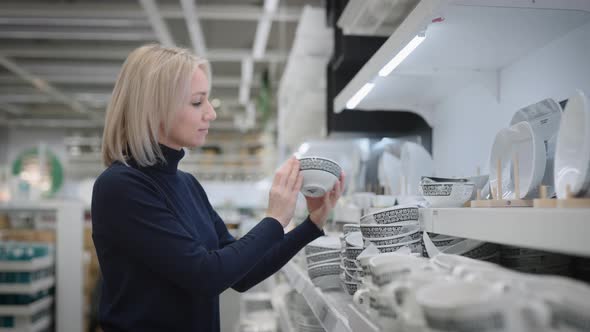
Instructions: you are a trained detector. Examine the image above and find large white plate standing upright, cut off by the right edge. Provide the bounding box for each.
[553,91,590,199]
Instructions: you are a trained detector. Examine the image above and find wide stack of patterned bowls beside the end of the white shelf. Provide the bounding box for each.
[360,205,422,254]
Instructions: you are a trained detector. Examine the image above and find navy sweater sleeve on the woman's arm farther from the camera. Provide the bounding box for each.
[192,178,324,292]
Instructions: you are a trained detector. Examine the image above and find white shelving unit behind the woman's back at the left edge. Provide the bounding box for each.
[0,201,84,332]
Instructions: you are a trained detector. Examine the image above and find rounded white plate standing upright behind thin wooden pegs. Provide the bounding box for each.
[489,122,546,199]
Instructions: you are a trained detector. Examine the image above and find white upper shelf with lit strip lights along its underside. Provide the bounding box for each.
[334,0,590,118]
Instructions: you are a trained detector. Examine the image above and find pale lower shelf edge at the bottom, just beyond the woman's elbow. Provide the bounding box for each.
[282,262,379,332]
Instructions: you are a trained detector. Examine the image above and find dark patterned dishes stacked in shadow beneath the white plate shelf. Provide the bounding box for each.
[500,246,571,276]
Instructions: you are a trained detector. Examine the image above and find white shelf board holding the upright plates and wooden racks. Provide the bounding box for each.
[420,208,590,257]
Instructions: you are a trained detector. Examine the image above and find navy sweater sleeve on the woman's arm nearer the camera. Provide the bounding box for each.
[92,167,284,296]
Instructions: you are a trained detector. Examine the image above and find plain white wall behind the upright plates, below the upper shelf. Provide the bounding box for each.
[433,19,590,176]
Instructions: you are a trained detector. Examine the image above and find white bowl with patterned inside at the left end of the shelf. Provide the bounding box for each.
[420,182,475,207]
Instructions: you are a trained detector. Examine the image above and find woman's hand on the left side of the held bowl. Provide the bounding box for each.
[266,157,303,228]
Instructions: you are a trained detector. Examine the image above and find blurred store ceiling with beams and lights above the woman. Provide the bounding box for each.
[0,0,322,131]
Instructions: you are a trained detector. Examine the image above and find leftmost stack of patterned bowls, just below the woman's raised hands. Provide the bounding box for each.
[305,236,341,289]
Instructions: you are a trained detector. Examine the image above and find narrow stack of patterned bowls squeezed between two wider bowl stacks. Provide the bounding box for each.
[340,232,364,295]
